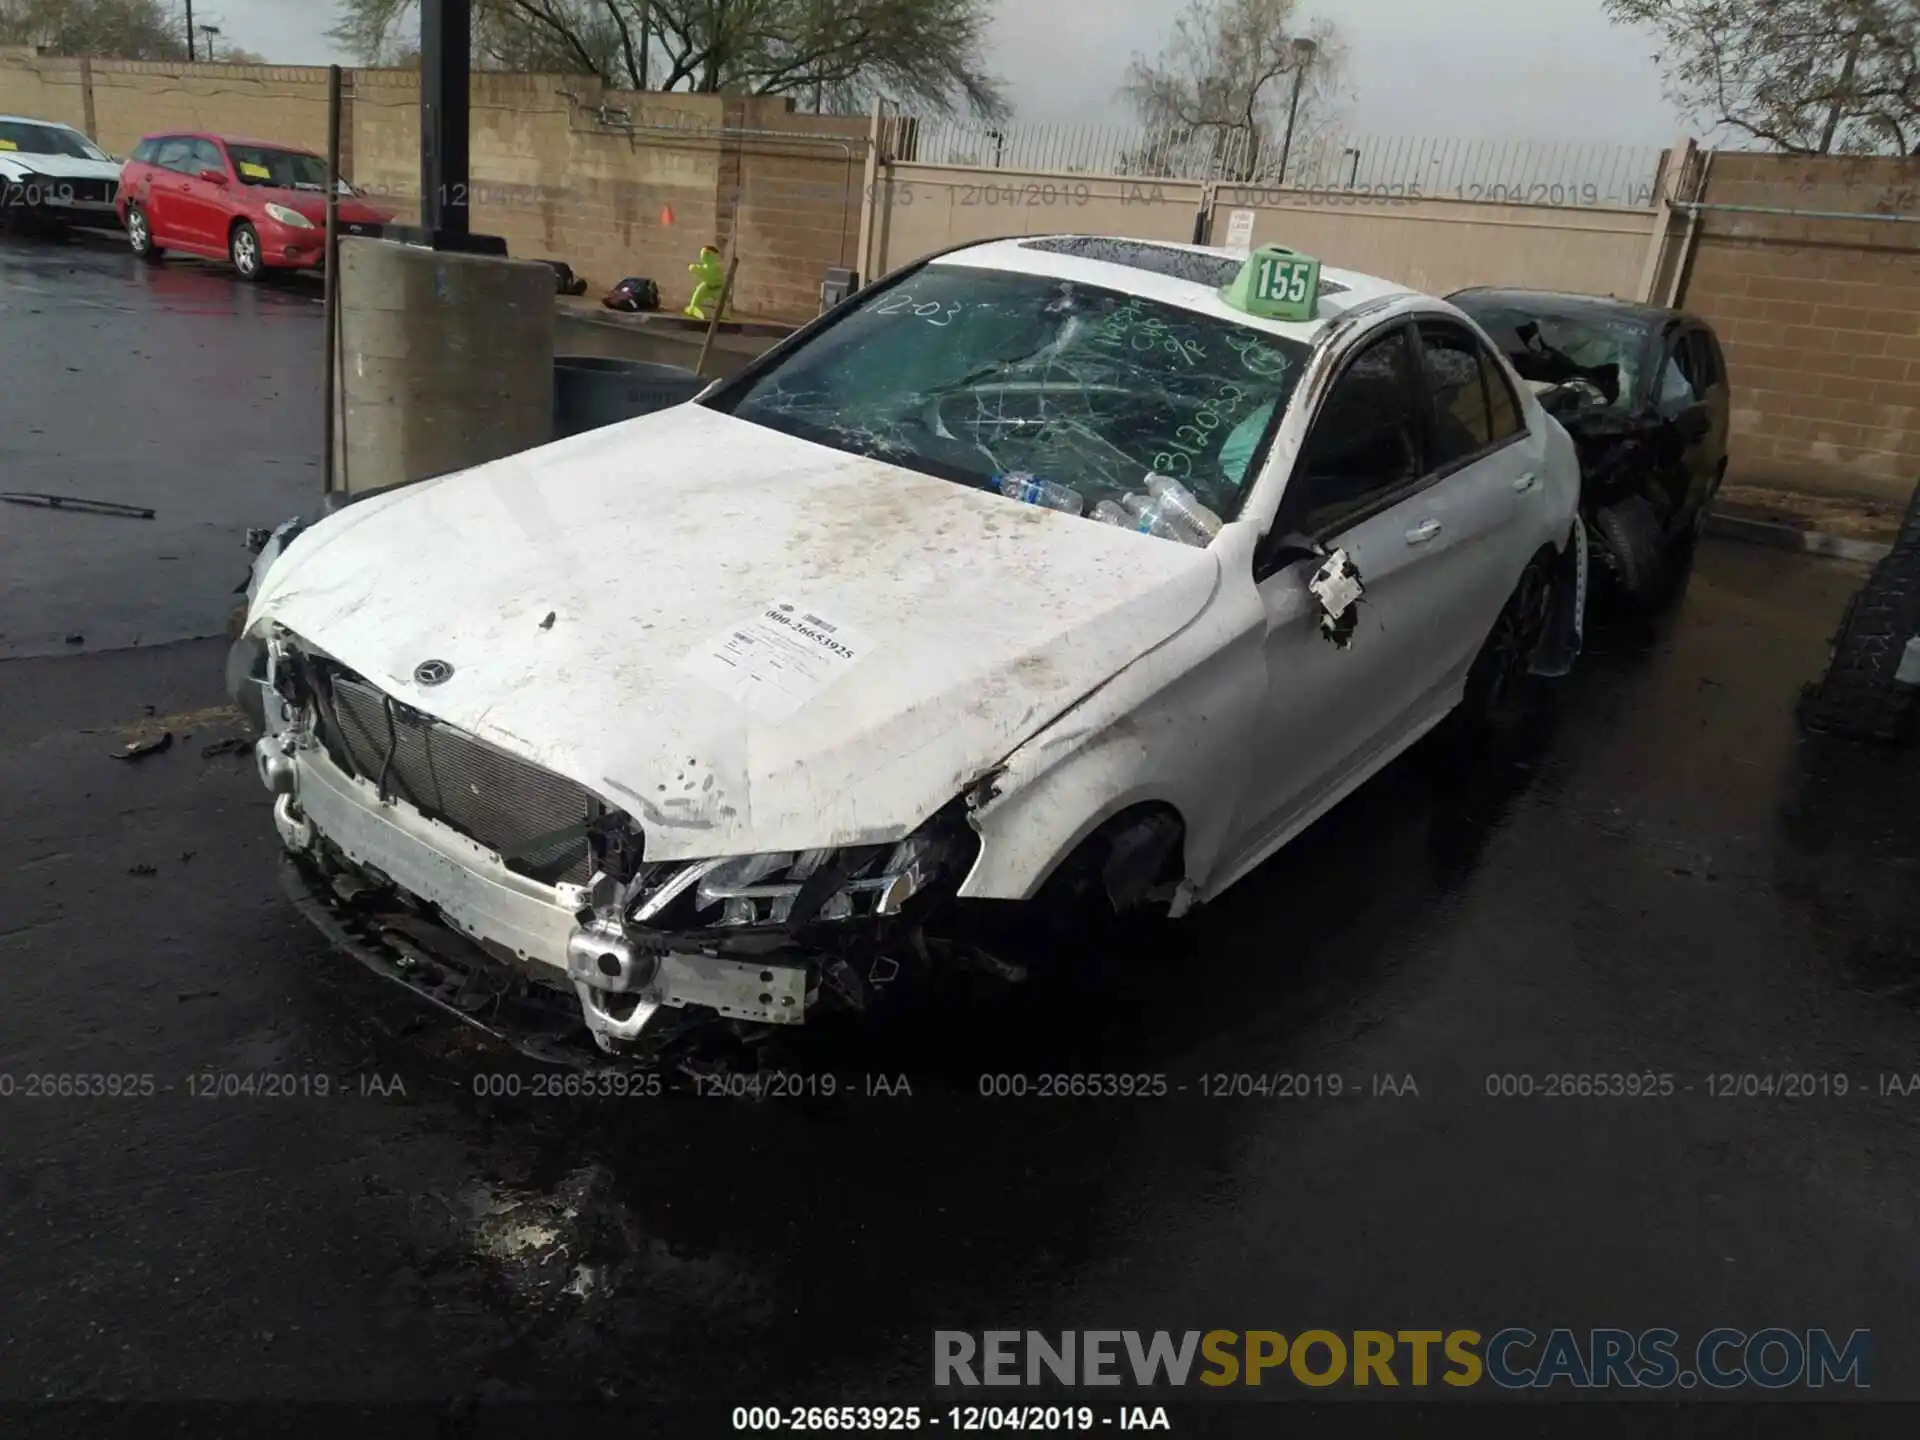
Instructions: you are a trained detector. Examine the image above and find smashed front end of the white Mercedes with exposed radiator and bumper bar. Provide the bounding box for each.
[243,632,993,1060]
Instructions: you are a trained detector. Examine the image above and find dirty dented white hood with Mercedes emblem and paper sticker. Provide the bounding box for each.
[250,405,1217,858]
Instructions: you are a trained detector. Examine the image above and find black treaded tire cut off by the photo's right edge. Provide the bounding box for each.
[1799,488,1920,745]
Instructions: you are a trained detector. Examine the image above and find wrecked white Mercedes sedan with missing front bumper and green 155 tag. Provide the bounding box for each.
[230,236,1586,1054]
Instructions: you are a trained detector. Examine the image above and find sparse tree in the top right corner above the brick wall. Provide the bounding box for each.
[1601,0,1920,156]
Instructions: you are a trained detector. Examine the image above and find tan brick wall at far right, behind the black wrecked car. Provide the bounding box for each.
[1682,154,1920,499]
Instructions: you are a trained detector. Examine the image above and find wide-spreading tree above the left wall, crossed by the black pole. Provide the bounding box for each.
[332,0,1006,117]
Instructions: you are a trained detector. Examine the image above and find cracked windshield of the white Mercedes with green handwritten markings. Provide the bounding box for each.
[722,265,1308,545]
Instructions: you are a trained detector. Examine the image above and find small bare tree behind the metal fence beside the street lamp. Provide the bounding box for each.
[1121,0,1346,180]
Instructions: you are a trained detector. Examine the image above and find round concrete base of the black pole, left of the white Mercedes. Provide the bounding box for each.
[328,236,555,493]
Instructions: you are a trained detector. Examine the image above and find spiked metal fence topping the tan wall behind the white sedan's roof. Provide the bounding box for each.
[897,121,1663,209]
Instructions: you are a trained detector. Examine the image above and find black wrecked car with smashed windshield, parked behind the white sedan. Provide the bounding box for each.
[1448,288,1728,609]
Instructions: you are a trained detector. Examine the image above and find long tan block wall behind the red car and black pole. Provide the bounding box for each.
[0,48,866,323]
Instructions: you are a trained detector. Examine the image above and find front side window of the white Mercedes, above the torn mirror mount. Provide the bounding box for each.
[1281,326,1421,536]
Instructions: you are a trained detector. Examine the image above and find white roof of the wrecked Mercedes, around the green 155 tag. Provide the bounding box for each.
[929,234,1421,344]
